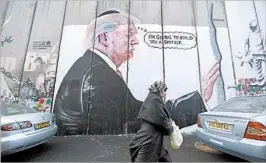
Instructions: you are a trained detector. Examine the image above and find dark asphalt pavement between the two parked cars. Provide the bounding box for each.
[1,134,245,162]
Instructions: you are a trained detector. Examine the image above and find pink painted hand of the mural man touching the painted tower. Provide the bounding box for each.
[201,62,220,102]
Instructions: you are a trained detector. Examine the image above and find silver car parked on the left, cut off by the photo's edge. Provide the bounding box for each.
[0,104,58,156]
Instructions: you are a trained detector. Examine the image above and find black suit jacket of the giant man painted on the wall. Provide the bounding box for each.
[54,50,206,135]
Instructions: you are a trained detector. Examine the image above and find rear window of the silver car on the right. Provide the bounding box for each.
[212,96,266,113]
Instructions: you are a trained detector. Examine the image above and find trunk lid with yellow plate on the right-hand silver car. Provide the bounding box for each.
[200,112,260,140]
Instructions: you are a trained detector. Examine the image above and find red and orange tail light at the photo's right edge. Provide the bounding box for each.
[245,121,266,141]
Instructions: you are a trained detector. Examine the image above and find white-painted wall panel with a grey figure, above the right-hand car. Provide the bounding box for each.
[225,1,266,95]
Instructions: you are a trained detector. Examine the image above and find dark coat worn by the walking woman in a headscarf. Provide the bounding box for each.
[129,93,173,162]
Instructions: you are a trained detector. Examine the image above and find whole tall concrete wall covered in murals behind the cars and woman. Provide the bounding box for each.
[0,0,266,135]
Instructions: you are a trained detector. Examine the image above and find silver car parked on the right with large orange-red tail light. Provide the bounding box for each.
[196,95,266,161]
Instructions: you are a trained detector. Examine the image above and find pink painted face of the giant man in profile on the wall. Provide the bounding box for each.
[95,22,139,67]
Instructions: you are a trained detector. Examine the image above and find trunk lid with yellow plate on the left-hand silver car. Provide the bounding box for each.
[8,113,53,135]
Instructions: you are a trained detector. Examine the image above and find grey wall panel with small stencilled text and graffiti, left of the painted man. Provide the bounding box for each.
[20,1,66,111]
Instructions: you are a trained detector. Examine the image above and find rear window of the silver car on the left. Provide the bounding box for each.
[0,104,37,116]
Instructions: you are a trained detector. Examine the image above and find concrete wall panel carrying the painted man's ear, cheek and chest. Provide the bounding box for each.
[83,0,129,134]
